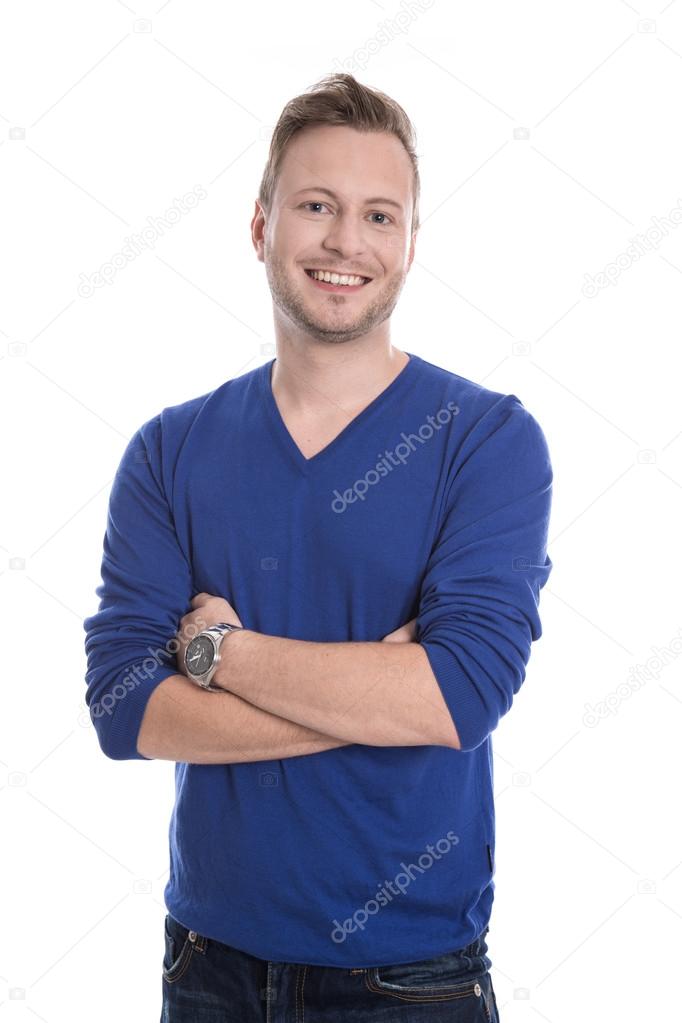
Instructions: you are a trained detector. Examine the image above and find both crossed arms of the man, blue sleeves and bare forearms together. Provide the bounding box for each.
[94,395,552,764]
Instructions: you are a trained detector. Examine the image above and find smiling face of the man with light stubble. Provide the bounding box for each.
[252,125,415,344]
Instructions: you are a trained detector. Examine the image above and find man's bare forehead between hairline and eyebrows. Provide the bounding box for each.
[276,125,412,206]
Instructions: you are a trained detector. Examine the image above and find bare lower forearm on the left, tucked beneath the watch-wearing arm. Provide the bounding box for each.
[137,674,351,764]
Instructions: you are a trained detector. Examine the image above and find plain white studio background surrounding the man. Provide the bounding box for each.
[0,0,682,1023]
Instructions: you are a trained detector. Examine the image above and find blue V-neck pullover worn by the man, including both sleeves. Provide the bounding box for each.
[84,353,552,968]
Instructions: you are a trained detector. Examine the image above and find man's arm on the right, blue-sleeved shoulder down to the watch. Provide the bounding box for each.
[193,395,552,751]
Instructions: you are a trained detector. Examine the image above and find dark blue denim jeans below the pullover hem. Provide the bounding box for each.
[161,914,499,1023]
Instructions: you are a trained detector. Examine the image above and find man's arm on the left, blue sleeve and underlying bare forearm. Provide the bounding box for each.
[83,412,414,763]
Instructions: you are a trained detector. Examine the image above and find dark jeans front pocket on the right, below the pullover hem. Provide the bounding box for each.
[365,938,494,1021]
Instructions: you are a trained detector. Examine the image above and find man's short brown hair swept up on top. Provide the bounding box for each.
[258,74,419,233]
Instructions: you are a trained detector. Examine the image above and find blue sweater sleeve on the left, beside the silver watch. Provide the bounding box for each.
[83,413,192,760]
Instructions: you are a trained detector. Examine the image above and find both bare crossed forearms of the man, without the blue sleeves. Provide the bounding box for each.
[137,594,459,763]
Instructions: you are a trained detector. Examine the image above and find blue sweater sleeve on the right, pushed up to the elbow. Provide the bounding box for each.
[416,395,553,751]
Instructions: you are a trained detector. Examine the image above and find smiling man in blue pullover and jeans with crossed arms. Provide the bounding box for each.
[84,75,552,1023]
